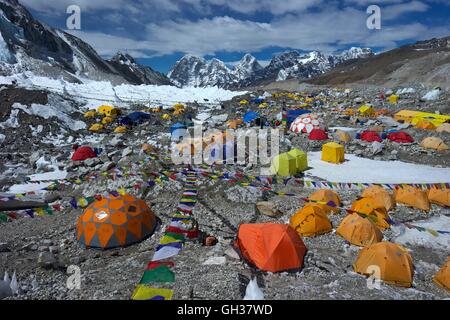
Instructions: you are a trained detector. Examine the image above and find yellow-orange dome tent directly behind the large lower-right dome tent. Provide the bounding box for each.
[336,213,383,247]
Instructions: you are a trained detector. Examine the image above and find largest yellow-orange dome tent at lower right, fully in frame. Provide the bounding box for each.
[353,241,414,288]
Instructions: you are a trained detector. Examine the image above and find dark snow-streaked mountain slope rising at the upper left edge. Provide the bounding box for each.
[0,0,167,84]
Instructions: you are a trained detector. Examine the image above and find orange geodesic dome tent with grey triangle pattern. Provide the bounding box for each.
[77,195,157,249]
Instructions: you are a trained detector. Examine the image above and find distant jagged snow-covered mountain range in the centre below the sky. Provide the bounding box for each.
[168,47,374,87]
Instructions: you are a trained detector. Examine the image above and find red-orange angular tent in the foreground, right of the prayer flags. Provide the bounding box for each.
[235,223,306,272]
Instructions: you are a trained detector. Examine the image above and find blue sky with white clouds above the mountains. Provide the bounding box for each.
[19,0,450,72]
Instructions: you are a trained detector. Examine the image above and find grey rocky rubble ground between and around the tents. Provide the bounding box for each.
[0,86,450,300]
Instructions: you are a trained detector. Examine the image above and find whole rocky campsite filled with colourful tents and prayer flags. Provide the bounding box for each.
[0,86,450,300]
